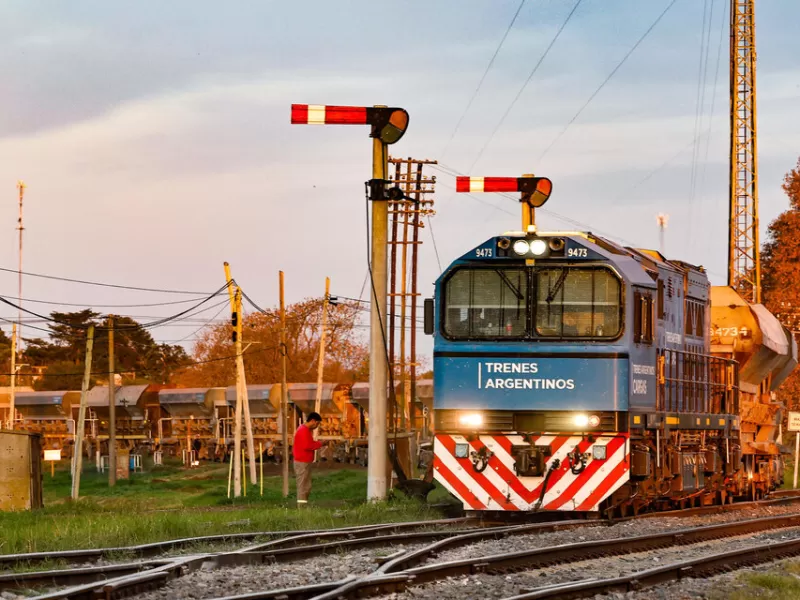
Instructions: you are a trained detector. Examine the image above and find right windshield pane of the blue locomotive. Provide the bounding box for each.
[535,268,621,338]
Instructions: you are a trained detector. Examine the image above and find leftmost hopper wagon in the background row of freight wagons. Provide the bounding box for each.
[7,391,81,458]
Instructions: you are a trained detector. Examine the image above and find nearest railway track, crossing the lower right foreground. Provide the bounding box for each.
[236,514,800,600]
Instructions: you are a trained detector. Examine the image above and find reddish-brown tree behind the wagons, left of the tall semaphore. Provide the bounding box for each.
[177,298,369,386]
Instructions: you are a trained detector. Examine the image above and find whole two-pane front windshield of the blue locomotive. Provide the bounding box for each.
[443,267,622,339]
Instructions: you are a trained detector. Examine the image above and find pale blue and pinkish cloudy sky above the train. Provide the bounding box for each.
[0,0,800,360]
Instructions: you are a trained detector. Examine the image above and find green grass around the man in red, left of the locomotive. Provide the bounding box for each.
[0,461,460,554]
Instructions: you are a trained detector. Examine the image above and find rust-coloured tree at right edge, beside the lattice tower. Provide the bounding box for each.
[761,159,800,408]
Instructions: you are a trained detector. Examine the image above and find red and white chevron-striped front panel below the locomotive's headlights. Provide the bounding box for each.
[433,433,630,511]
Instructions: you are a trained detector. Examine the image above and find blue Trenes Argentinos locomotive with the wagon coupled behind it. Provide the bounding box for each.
[432,231,795,514]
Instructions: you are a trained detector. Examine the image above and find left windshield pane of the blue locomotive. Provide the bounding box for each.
[444,269,528,339]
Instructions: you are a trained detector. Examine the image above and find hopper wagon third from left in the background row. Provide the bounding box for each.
[157,387,228,458]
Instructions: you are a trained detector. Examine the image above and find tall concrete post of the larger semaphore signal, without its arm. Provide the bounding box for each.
[367,137,389,500]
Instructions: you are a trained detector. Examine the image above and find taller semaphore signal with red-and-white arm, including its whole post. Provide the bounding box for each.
[291,104,408,500]
